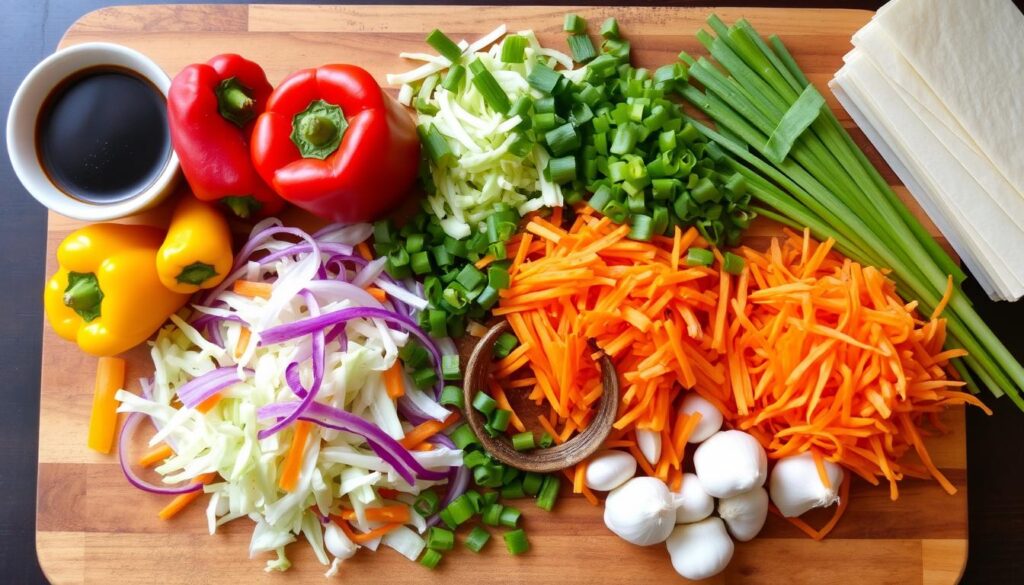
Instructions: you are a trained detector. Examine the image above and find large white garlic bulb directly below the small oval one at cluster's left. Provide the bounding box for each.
[604,477,677,546]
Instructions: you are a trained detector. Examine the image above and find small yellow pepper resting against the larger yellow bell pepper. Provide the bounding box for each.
[157,194,233,294]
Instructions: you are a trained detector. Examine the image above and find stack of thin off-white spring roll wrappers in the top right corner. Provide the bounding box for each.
[829,0,1024,300]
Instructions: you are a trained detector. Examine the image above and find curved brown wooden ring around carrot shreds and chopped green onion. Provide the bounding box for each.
[463,321,618,473]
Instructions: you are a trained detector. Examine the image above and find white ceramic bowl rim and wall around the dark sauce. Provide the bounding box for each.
[7,43,178,221]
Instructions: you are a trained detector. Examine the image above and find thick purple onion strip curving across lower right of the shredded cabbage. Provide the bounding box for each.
[258,402,446,486]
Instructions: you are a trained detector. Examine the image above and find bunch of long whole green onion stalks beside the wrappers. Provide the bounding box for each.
[677,15,1024,410]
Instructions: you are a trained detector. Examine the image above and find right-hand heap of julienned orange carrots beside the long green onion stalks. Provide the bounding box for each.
[720,228,989,499]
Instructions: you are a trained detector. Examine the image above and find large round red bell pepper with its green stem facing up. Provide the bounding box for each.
[252,65,420,222]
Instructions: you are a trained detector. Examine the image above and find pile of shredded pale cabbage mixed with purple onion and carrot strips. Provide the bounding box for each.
[117,220,468,573]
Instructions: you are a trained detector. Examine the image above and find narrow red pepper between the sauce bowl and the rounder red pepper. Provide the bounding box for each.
[167,54,285,217]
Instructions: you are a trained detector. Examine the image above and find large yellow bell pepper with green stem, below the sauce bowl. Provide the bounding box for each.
[43,223,188,357]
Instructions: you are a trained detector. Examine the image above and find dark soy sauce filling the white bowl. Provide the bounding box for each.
[36,66,171,204]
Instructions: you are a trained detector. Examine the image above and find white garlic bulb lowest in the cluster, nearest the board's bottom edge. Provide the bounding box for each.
[666,516,735,581]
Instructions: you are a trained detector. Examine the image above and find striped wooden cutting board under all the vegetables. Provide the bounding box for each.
[36,6,967,585]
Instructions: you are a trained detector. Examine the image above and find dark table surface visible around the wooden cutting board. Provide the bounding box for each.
[0,0,1024,585]
